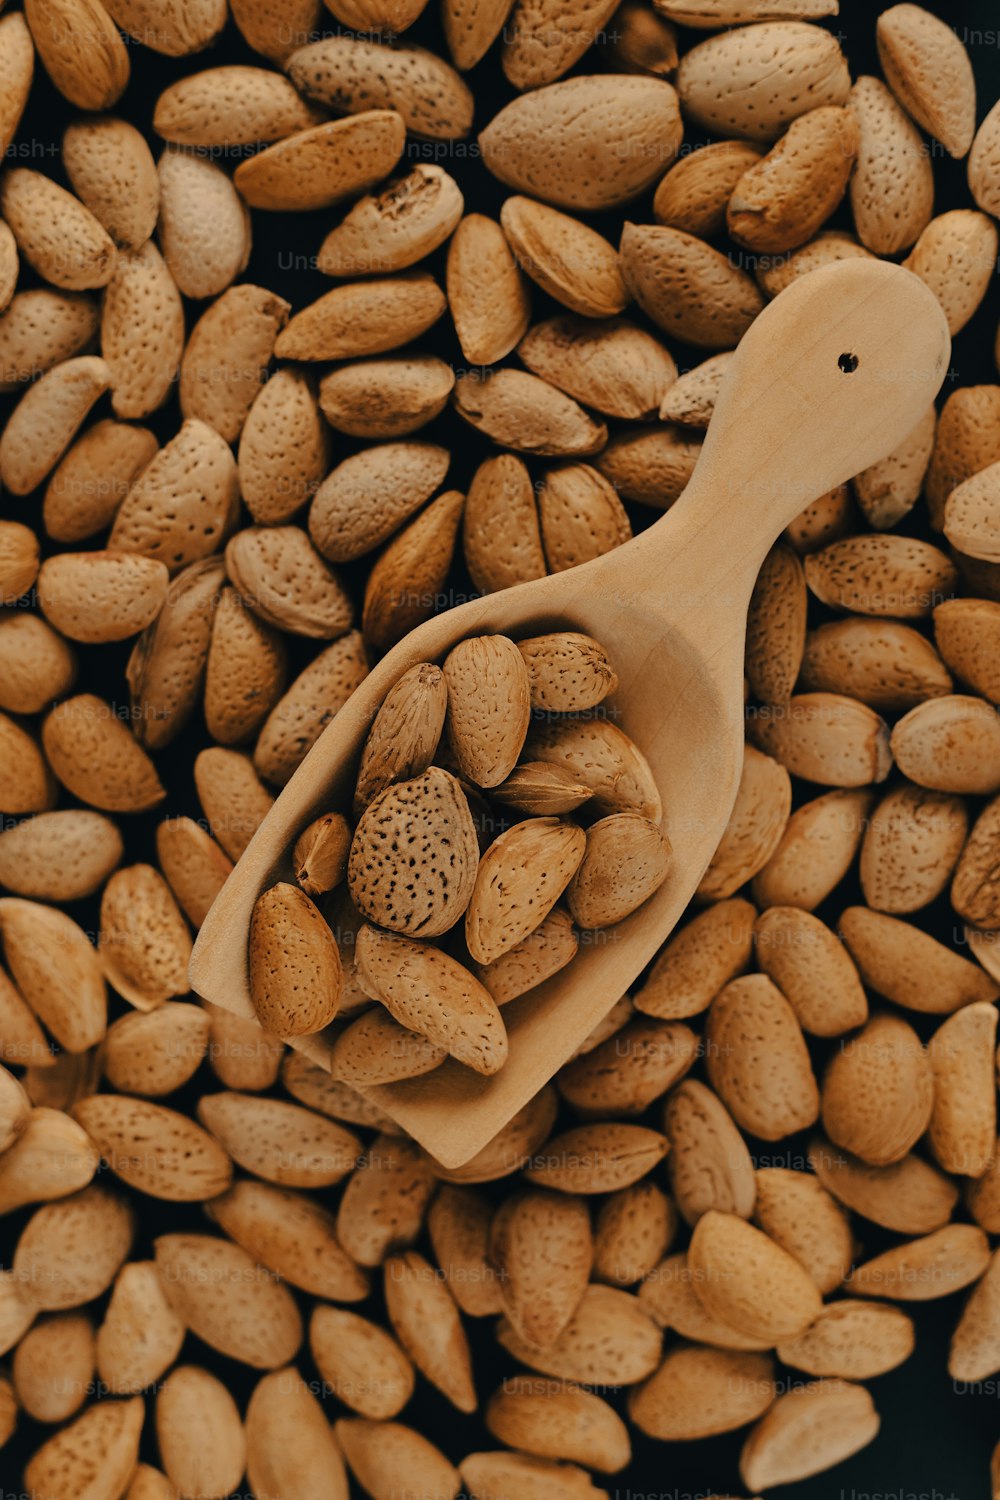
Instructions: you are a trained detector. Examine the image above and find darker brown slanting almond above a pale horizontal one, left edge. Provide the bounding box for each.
[42,693,166,813]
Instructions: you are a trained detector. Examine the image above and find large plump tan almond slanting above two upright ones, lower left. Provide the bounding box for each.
[153,1233,303,1370]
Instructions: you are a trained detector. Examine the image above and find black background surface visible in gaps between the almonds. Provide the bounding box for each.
[0,0,1000,1500]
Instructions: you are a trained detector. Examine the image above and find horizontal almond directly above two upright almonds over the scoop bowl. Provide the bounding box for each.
[451,369,607,458]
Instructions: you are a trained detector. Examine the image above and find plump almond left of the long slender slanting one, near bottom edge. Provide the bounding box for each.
[309,1305,414,1422]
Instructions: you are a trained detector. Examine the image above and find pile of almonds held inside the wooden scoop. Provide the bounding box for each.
[249,632,670,1088]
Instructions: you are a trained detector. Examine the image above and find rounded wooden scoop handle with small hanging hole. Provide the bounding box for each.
[654,258,951,567]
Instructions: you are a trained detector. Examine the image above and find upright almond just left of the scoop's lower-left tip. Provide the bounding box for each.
[99,864,192,1011]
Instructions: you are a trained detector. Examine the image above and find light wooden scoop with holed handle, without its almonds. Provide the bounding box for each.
[190,260,949,1167]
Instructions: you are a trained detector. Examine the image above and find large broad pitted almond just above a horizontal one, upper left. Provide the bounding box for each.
[108,419,240,573]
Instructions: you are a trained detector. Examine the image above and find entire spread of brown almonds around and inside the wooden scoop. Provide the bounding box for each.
[0,0,1000,1500]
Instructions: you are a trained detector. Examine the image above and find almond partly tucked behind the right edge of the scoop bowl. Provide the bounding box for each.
[697,744,792,902]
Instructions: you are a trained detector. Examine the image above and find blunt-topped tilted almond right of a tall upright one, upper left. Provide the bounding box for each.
[180,282,291,443]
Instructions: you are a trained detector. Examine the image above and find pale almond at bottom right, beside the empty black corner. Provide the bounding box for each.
[739,1380,879,1490]
